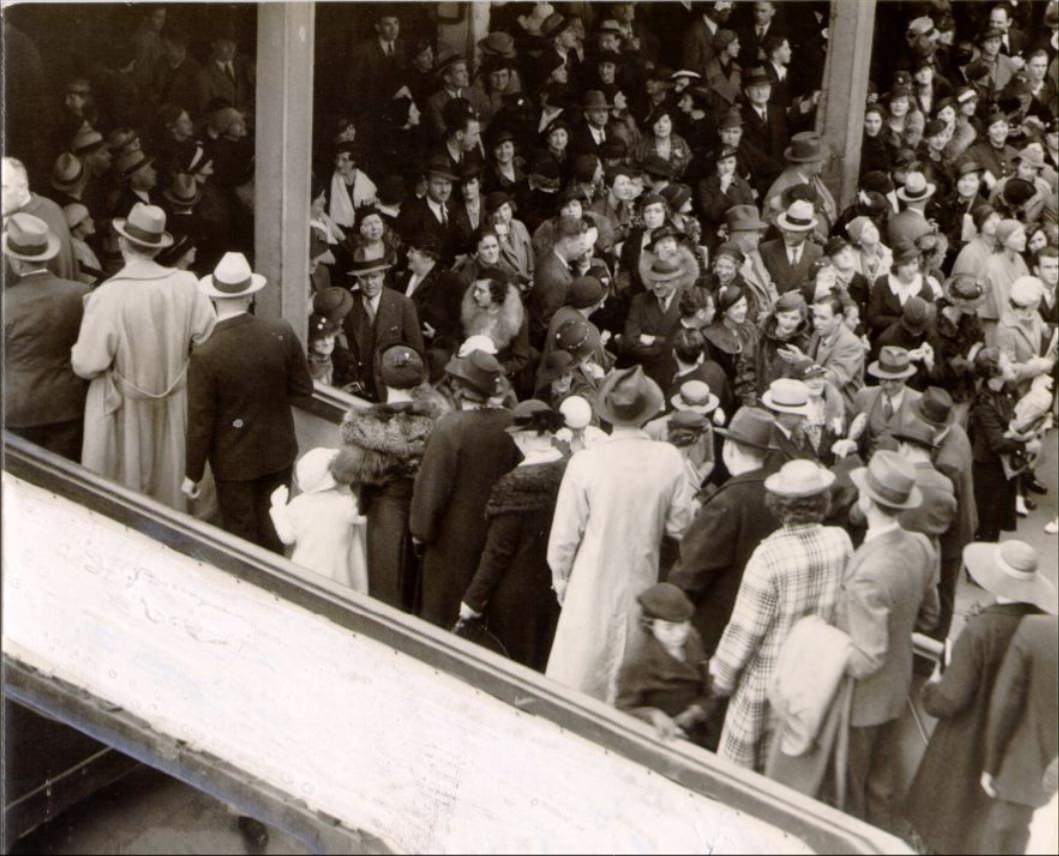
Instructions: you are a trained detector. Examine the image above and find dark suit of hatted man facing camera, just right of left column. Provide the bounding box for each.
[342,288,423,400]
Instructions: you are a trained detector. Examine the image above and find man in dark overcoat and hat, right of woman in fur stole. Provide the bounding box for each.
[409,351,519,628]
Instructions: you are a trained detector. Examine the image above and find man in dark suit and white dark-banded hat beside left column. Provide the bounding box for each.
[181,252,312,553]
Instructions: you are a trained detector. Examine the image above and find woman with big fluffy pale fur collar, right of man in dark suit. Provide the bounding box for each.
[460,270,534,398]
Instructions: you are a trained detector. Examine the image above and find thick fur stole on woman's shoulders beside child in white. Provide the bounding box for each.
[341,388,446,486]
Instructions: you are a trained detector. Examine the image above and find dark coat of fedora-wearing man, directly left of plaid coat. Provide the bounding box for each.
[669,469,776,655]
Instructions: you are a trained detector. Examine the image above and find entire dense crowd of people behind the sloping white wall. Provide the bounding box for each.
[3,0,1059,853]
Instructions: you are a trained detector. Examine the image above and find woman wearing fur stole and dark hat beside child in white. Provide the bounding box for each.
[341,344,448,612]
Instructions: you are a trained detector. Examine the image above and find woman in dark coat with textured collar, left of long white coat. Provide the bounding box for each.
[460,398,567,672]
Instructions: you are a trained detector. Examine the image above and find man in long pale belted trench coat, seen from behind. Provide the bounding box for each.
[71,202,216,511]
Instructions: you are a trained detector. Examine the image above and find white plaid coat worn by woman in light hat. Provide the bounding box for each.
[710,523,854,771]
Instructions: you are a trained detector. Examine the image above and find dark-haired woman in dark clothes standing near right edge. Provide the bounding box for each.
[969,347,1041,541]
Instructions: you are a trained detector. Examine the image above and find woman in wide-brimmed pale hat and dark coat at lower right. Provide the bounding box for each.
[905,541,1054,853]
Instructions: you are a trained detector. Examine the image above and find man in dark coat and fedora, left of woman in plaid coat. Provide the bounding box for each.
[669,407,776,652]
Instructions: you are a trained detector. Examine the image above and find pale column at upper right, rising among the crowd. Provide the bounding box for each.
[816,0,881,210]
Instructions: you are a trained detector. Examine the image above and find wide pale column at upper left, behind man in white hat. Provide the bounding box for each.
[254,2,315,341]
